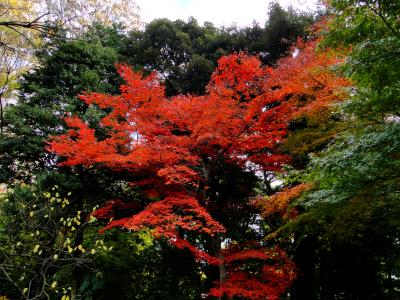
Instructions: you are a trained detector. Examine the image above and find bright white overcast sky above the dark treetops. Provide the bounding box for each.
[136,0,317,26]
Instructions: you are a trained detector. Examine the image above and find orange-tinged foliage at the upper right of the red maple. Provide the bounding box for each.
[267,39,350,118]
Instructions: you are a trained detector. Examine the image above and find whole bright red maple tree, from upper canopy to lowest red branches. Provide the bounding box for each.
[49,39,346,299]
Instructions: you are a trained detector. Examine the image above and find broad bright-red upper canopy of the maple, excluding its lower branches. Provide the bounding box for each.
[50,54,288,176]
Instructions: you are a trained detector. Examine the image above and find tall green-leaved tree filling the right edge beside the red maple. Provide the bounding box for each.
[276,0,400,299]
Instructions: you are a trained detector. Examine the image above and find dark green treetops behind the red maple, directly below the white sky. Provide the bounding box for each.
[124,4,315,96]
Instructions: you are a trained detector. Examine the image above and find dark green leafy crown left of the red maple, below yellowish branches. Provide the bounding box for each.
[0,25,122,181]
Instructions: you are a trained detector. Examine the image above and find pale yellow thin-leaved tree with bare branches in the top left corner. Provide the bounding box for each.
[0,0,140,133]
